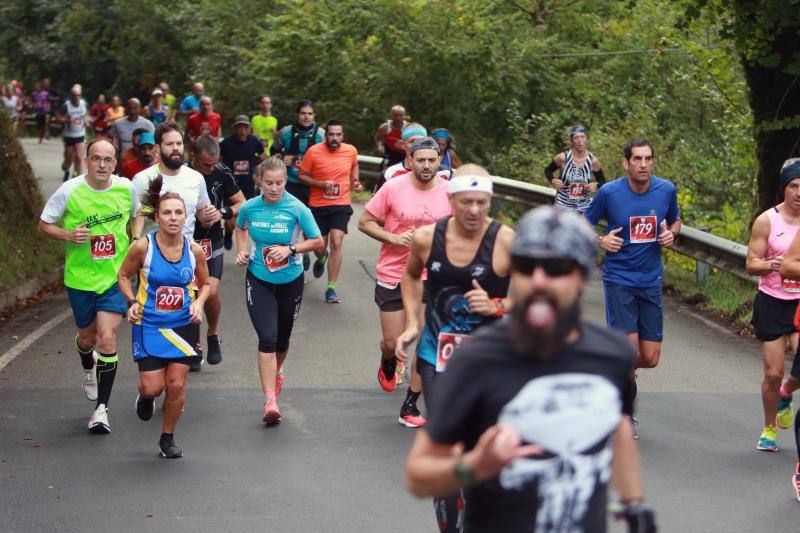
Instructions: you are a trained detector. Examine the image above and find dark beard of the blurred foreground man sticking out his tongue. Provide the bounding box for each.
[511,292,581,359]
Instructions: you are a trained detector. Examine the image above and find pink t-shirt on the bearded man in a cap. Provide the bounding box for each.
[366,174,451,285]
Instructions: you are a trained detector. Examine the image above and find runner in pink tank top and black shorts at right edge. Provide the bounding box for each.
[747,160,800,452]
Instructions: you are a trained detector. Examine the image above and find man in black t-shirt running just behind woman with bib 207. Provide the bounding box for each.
[189,135,247,365]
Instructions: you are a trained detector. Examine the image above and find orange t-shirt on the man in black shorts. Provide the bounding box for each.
[300,142,358,207]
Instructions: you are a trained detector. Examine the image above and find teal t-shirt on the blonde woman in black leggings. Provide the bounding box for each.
[236,192,320,284]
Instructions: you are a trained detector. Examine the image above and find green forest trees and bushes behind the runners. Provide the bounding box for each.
[0,0,800,322]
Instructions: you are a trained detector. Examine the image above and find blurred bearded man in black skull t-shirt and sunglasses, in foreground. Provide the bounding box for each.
[406,207,656,533]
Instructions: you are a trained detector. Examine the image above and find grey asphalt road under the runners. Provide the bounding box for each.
[0,141,800,532]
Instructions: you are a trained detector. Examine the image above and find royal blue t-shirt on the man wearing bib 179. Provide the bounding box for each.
[584,176,680,287]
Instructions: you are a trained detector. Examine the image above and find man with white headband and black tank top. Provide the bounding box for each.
[396,164,514,531]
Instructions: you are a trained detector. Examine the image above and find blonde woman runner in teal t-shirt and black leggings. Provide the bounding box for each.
[236,157,324,425]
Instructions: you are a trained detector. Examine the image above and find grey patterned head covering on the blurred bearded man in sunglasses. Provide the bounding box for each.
[511,206,598,276]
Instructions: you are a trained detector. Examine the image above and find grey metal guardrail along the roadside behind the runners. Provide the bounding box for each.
[358,155,758,282]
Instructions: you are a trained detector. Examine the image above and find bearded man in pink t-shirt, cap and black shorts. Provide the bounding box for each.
[358,137,451,427]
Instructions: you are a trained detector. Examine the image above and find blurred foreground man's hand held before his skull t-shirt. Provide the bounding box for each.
[464,424,544,481]
